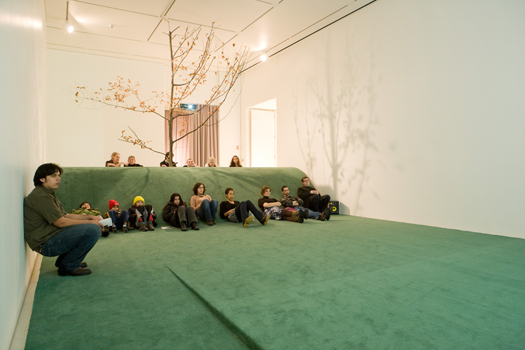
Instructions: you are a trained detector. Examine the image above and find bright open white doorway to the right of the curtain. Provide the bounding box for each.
[250,99,277,167]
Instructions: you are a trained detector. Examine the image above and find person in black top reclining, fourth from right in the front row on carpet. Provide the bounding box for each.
[219,187,270,227]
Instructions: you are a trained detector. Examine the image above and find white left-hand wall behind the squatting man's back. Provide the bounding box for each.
[0,0,45,350]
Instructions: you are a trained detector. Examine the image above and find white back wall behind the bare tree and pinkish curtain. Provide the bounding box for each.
[47,50,240,167]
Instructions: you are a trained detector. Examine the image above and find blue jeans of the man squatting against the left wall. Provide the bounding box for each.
[40,224,101,272]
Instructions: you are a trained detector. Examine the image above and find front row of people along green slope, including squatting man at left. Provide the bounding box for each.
[24,163,331,276]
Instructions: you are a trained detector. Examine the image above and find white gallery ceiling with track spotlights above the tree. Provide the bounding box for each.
[45,0,375,66]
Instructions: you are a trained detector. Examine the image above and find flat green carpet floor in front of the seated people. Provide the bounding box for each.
[26,216,525,350]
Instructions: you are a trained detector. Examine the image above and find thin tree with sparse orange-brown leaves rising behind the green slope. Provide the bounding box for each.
[75,26,249,166]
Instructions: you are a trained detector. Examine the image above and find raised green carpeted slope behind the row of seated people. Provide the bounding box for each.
[56,168,305,214]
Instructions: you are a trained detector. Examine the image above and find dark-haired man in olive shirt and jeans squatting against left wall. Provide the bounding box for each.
[24,163,102,276]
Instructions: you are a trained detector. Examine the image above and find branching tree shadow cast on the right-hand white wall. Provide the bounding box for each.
[292,32,380,215]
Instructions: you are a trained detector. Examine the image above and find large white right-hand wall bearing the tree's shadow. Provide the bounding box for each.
[241,0,525,238]
